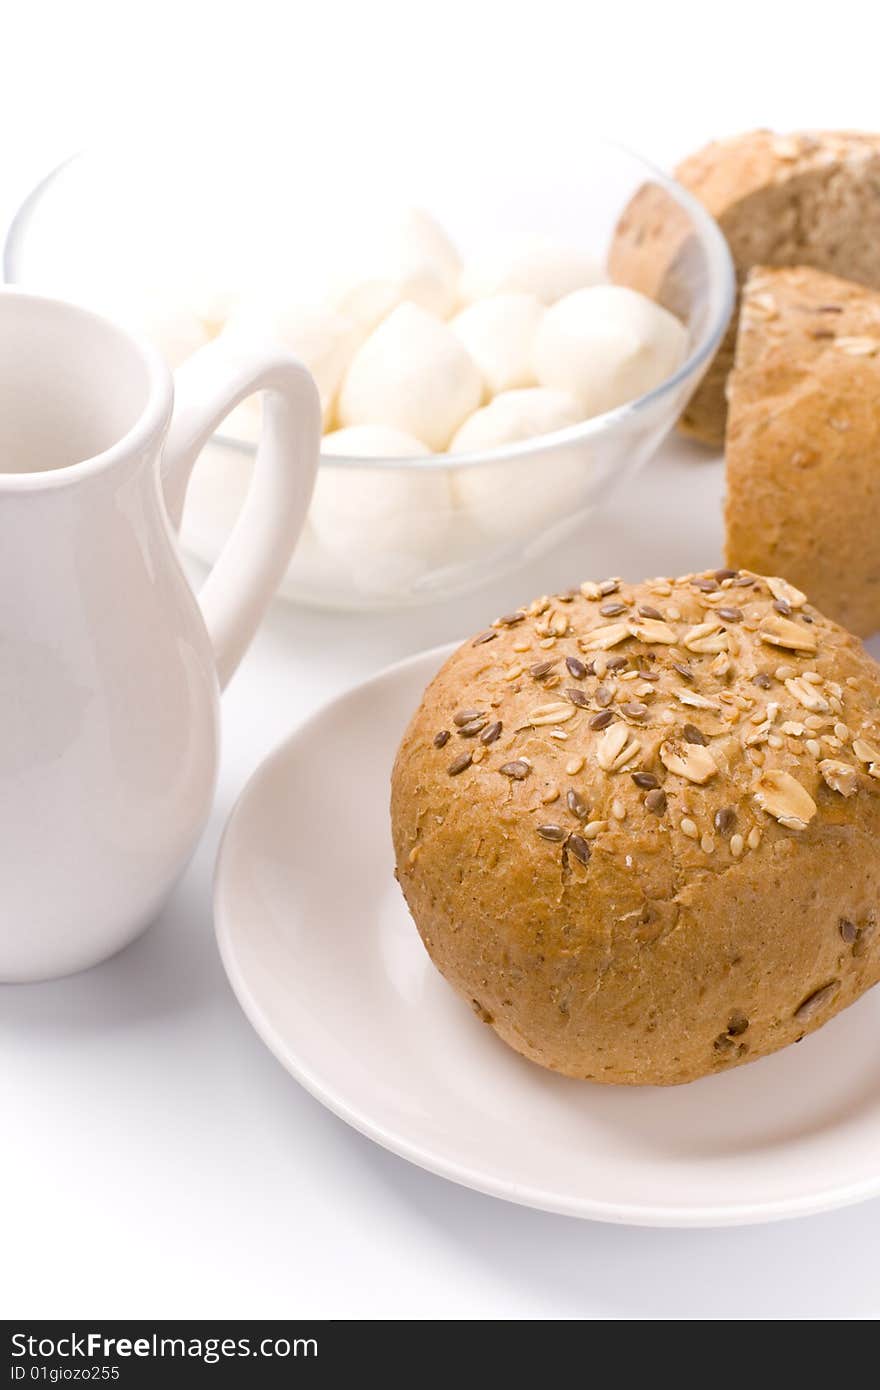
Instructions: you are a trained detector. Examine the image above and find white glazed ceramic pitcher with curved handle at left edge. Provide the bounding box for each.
[0,291,321,981]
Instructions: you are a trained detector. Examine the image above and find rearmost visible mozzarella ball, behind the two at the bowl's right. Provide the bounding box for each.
[459,238,605,304]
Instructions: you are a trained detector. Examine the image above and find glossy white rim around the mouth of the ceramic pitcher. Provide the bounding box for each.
[0,285,174,492]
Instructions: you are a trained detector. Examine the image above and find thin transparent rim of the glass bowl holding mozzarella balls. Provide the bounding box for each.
[3,138,735,471]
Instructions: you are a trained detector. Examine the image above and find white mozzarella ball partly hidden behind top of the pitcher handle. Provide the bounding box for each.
[224,302,363,425]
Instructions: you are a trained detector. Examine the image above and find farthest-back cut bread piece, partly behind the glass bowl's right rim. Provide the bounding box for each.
[609,131,880,445]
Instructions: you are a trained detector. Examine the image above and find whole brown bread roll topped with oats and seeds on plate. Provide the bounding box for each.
[391,570,880,1086]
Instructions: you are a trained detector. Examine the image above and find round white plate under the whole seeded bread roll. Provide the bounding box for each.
[214,649,880,1226]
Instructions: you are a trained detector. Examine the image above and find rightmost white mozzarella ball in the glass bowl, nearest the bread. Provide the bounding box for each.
[535,285,688,418]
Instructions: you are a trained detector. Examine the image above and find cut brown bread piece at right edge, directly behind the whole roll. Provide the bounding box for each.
[726,267,880,637]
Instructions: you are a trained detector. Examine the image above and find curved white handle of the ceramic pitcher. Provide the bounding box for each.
[161,338,321,689]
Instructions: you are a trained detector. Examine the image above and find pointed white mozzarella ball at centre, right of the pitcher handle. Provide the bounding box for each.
[338,303,482,453]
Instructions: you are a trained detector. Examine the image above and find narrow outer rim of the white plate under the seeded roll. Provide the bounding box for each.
[211,642,880,1230]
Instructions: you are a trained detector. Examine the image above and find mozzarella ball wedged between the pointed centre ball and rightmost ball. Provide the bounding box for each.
[449,291,544,396]
